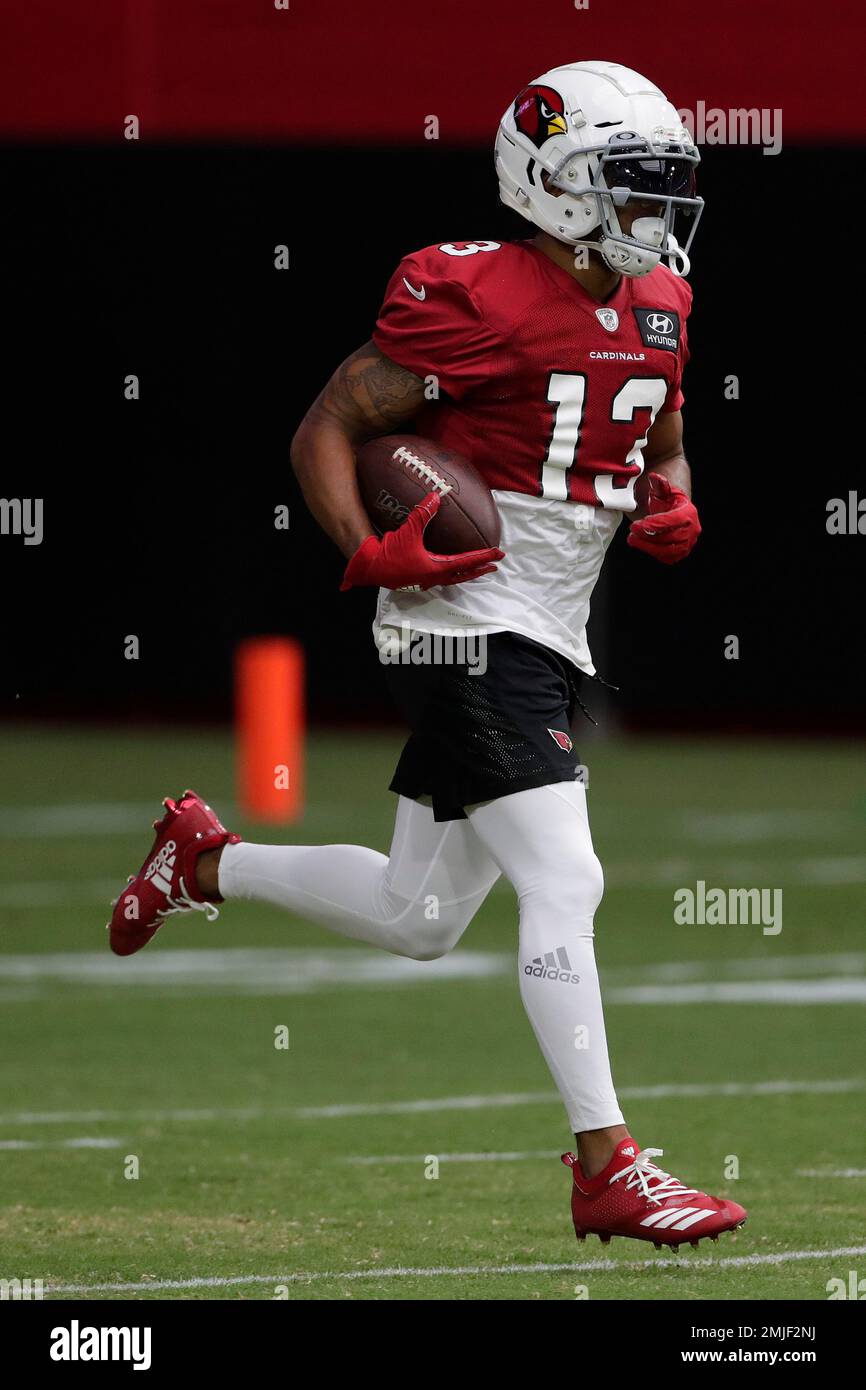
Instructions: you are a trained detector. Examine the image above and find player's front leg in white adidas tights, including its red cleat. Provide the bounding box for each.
[468,783,746,1248]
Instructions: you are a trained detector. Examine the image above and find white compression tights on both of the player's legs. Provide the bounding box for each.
[220,783,623,1133]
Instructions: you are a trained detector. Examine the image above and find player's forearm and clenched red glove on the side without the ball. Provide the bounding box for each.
[628,410,701,564]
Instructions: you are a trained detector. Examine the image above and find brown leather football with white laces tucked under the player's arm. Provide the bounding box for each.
[357,435,500,555]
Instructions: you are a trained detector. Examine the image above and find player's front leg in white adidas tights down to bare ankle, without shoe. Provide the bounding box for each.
[467,781,627,1172]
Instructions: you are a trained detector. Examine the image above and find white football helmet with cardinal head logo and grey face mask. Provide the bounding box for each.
[495,61,703,275]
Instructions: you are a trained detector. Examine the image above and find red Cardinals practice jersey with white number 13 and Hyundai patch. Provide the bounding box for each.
[373,240,692,512]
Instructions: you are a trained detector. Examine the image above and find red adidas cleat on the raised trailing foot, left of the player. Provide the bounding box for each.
[107,791,240,955]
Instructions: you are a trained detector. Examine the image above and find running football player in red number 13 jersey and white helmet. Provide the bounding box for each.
[111,61,745,1247]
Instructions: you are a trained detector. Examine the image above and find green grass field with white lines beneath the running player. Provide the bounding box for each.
[0,728,866,1300]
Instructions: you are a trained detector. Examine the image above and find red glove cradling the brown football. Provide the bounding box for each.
[341,492,505,589]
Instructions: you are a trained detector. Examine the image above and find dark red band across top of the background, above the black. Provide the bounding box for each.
[0,0,866,145]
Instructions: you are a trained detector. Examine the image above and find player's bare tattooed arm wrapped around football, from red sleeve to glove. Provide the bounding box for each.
[292,342,424,557]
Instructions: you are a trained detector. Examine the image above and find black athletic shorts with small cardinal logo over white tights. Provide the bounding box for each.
[385,632,581,820]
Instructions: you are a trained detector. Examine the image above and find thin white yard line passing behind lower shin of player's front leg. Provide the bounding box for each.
[0,1077,866,1126]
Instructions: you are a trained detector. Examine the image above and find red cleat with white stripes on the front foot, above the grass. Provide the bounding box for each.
[562,1136,746,1250]
